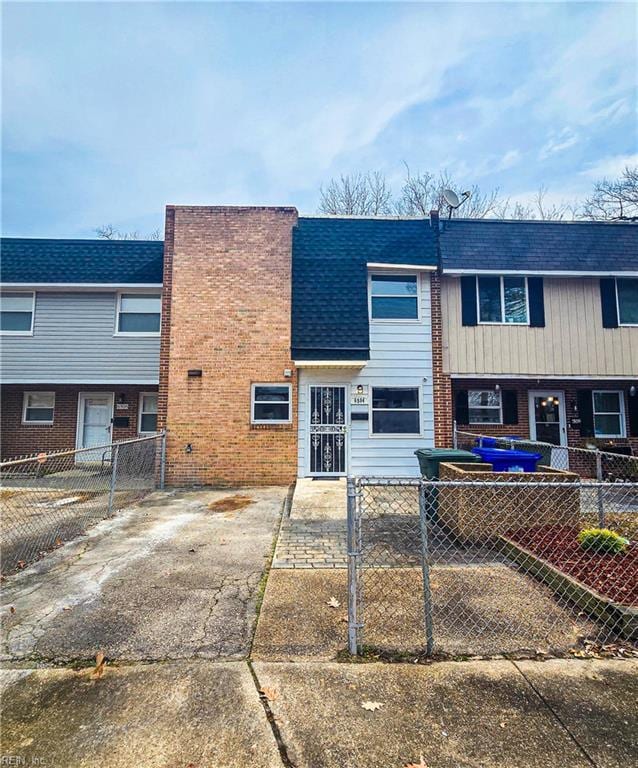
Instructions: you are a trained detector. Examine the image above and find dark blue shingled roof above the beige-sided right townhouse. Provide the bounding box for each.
[440,219,638,273]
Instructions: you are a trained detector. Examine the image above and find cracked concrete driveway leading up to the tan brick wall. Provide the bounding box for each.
[1,488,287,663]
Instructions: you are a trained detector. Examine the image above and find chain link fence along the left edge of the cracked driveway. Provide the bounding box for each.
[0,433,166,574]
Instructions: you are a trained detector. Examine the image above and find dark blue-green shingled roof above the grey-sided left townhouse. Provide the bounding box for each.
[0,237,164,285]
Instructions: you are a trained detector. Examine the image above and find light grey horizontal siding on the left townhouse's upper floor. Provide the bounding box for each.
[0,291,160,384]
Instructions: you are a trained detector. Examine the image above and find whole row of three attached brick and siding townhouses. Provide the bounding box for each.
[0,206,638,484]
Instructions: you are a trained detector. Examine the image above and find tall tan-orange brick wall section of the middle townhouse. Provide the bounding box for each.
[160,206,297,485]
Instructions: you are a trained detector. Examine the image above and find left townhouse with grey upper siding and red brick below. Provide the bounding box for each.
[0,238,164,460]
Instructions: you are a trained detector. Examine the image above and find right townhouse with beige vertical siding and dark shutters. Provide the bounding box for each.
[440,219,638,460]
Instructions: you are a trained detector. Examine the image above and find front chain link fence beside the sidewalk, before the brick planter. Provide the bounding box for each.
[348,473,638,656]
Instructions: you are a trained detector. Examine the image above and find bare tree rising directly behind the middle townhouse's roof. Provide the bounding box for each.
[319,171,392,216]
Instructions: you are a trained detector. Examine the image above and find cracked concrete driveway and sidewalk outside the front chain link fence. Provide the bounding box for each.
[0,488,638,768]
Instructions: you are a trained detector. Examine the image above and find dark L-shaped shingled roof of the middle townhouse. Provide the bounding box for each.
[292,217,437,360]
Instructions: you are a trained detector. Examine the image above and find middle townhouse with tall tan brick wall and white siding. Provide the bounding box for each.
[160,206,442,483]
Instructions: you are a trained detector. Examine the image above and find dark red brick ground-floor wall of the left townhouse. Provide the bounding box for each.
[0,384,157,459]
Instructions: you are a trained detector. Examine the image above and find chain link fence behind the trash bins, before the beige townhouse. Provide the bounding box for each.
[454,425,638,483]
